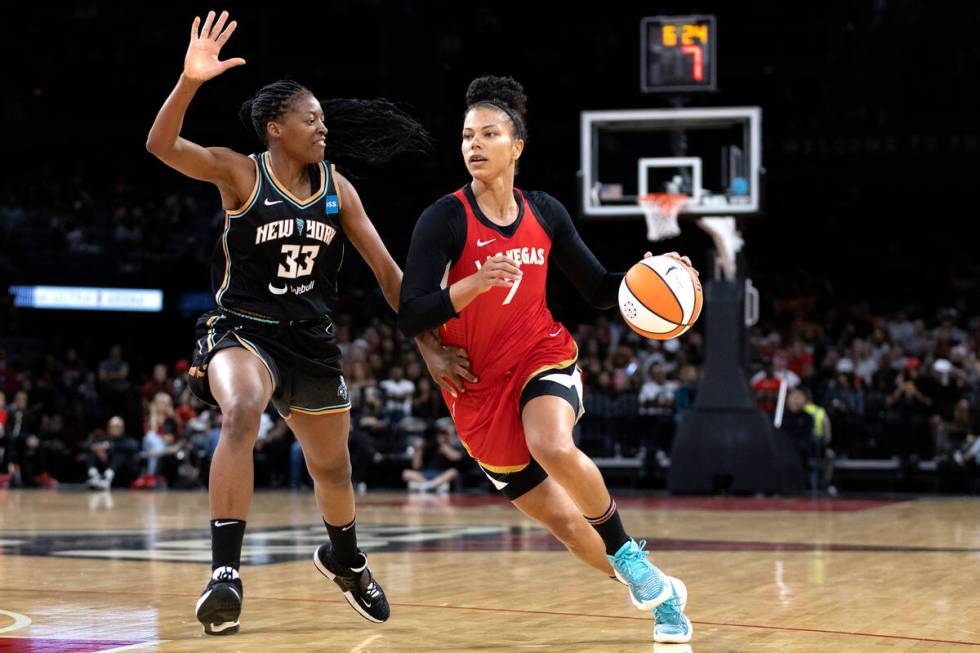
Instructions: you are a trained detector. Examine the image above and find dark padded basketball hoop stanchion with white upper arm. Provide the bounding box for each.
[667,218,804,494]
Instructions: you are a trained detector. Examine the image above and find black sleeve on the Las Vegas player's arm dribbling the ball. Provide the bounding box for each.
[534,193,624,308]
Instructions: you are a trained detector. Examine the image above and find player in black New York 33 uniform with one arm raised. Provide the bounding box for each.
[146,12,466,635]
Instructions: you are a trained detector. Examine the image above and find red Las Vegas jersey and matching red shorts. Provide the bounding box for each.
[439,190,578,473]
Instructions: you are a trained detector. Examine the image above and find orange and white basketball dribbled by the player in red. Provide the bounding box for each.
[619,256,703,340]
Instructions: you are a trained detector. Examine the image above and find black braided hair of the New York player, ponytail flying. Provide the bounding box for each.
[238,79,432,170]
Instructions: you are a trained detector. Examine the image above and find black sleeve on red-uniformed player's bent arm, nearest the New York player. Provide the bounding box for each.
[398,196,466,338]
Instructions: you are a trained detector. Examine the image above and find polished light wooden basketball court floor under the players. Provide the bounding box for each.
[0,491,980,653]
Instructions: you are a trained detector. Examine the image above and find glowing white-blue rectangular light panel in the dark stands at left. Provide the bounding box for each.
[10,286,163,313]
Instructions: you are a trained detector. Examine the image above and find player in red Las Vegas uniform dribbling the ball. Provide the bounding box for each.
[399,77,692,642]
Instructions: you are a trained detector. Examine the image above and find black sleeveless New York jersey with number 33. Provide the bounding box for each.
[211,152,344,321]
